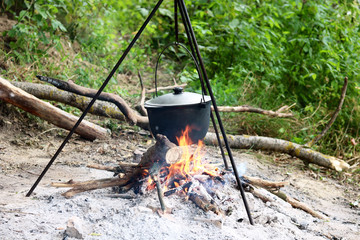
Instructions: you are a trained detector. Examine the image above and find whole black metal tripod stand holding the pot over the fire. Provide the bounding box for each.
[26,0,254,225]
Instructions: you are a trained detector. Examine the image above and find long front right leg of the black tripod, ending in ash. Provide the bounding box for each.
[178,0,254,225]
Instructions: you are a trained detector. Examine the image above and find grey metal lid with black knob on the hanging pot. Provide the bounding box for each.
[145,87,211,107]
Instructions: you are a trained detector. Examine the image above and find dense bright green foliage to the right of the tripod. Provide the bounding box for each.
[183,0,360,156]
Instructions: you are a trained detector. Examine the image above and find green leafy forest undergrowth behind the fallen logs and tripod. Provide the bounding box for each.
[0,0,360,178]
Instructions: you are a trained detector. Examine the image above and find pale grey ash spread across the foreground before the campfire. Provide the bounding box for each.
[0,166,356,239]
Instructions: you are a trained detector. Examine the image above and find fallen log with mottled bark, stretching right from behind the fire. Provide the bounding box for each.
[204,133,350,171]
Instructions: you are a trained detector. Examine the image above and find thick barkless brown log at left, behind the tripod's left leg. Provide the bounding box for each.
[0,77,109,140]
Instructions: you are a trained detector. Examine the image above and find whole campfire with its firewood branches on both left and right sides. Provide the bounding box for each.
[52,127,325,222]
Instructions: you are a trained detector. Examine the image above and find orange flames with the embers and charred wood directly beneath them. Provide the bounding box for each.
[148,126,224,214]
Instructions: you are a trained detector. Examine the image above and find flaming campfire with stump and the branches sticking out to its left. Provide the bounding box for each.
[52,127,225,214]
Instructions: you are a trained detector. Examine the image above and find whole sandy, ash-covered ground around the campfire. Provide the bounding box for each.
[0,111,360,240]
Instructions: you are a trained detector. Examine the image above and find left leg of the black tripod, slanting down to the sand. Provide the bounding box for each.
[26,0,163,197]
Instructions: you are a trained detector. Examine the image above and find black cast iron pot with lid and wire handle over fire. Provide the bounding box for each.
[144,43,211,144]
